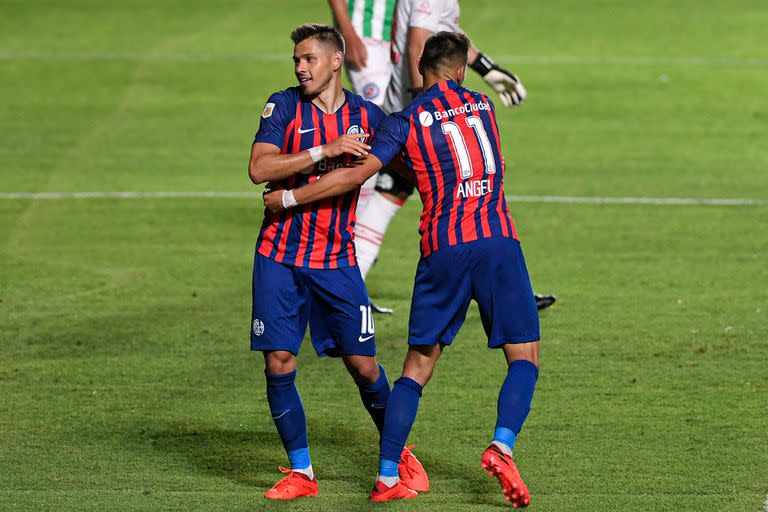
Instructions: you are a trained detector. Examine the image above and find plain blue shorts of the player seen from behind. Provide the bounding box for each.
[408,238,539,348]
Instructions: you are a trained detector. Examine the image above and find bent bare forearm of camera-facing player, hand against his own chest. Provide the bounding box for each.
[248,133,371,185]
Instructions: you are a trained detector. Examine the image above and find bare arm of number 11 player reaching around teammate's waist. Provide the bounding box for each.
[264,154,383,212]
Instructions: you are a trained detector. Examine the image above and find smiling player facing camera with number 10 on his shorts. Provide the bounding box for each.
[248,25,429,499]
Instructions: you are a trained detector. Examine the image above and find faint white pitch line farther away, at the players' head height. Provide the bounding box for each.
[0,50,768,67]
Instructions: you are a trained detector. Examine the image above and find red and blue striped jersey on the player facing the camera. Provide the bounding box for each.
[254,87,384,269]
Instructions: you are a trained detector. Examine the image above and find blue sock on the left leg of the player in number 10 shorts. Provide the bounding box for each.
[264,370,310,469]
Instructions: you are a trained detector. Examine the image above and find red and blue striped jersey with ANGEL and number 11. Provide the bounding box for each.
[370,81,517,256]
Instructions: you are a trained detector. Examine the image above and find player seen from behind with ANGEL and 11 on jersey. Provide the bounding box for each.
[265,32,539,507]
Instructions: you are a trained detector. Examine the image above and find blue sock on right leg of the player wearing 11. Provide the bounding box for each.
[493,360,539,448]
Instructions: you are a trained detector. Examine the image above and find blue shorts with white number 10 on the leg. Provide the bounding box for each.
[251,252,376,357]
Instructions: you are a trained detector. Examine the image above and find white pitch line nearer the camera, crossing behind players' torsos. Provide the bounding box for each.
[0,190,768,206]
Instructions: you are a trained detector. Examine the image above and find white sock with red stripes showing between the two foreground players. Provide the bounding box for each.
[355,191,402,279]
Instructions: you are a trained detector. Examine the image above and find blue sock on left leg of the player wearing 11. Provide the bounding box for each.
[379,377,422,468]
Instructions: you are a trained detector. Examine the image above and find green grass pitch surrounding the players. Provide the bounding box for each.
[0,0,768,512]
